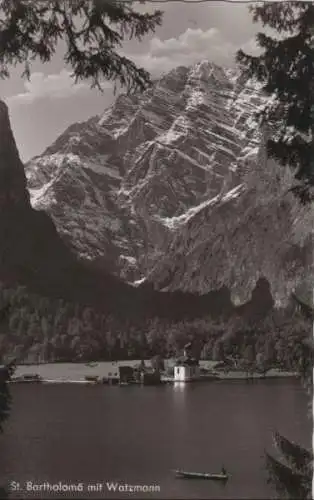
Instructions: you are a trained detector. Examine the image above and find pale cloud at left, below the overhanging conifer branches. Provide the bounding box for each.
[7,69,111,106]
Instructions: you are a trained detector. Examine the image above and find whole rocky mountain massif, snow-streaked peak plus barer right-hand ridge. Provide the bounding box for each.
[26,61,313,304]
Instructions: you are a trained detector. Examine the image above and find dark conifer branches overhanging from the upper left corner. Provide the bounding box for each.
[0,0,162,91]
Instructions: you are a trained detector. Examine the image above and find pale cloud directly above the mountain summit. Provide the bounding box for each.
[128,28,257,77]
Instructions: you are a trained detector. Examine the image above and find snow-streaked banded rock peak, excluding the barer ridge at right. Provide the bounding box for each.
[26,61,312,298]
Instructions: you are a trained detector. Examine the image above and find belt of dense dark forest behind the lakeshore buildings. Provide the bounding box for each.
[0,285,312,369]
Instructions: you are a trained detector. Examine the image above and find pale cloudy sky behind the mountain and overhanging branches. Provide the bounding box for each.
[0,1,257,161]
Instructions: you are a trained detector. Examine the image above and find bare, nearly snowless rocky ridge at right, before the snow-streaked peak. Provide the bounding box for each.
[147,133,314,306]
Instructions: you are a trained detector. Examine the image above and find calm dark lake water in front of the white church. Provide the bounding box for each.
[0,379,312,499]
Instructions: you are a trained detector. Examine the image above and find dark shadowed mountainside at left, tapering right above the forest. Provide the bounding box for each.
[0,97,245,318]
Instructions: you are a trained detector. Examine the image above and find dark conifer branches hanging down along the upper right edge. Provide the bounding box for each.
[236,1,314,202]
